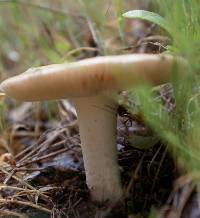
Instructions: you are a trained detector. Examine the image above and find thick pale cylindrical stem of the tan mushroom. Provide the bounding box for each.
[73,95,122,203]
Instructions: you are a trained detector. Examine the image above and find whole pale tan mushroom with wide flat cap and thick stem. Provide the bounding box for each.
[0,54,182,202]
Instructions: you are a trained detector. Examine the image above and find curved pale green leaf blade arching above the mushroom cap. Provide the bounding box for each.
[123,10,171,33]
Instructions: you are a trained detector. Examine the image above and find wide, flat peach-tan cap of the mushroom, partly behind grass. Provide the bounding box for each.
[0,54,183,101]
